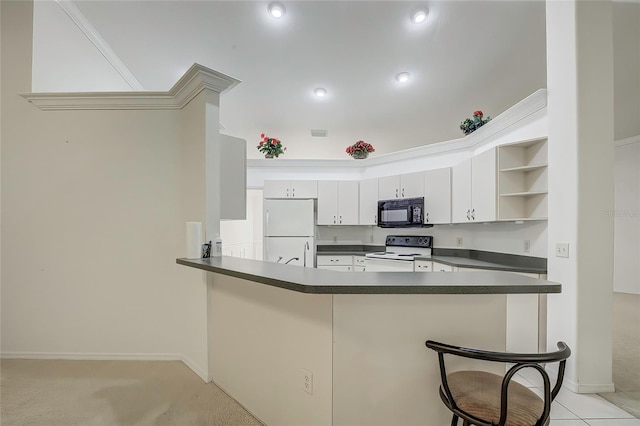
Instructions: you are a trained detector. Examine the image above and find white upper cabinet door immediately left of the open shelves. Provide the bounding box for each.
[471,148,497,222]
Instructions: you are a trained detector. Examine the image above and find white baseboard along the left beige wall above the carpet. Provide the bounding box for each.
[0,352,209,383]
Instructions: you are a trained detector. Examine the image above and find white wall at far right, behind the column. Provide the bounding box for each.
[610,138,640,294]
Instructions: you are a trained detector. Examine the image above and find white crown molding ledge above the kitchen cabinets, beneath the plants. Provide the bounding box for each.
[247,89,547,170]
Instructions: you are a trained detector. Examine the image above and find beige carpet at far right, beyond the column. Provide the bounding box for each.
[600,293,640,418]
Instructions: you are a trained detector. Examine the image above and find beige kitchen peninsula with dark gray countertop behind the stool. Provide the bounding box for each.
[177,256,561,426]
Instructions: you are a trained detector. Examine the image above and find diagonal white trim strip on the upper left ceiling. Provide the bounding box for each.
[54,0,145,90]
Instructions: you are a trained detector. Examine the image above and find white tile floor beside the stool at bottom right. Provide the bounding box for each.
[517,370,640,426]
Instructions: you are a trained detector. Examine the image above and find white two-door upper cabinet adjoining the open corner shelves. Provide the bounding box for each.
[451,148,496,223]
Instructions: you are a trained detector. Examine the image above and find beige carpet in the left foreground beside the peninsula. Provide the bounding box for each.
[0,359,262,426]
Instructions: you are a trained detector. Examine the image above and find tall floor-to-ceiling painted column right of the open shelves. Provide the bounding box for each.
[547,0,614,393]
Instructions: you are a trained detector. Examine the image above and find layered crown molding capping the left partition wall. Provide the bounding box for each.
[20,64,240,111]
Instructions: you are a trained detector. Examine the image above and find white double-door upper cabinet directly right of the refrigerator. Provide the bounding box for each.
[318,181,358,225]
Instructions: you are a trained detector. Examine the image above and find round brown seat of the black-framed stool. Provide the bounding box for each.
[447,371,544,426]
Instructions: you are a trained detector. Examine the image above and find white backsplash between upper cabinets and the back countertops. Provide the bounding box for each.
[317,221,547,257]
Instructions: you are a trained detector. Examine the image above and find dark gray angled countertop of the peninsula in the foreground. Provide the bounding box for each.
[176,256,561,294]
